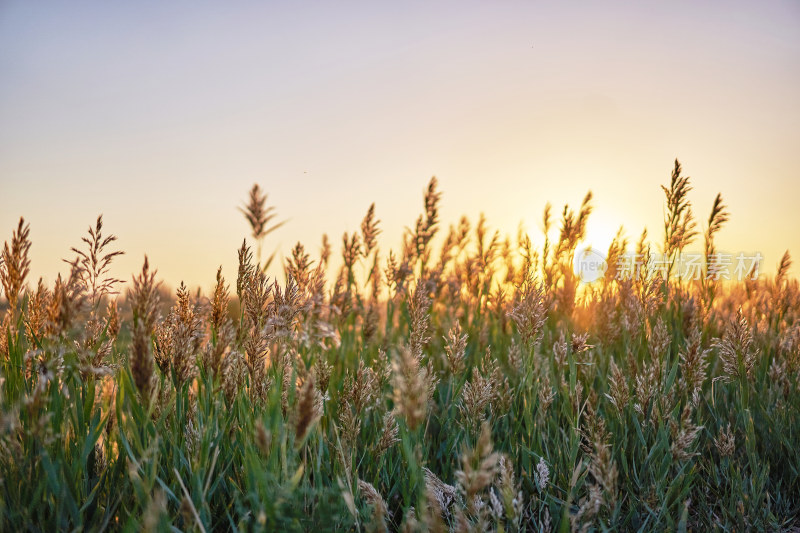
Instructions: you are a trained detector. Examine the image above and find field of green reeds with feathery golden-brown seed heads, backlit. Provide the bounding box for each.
[0,161,800,531]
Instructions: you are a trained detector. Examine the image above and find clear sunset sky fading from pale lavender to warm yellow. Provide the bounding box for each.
[0,0,800,290]
